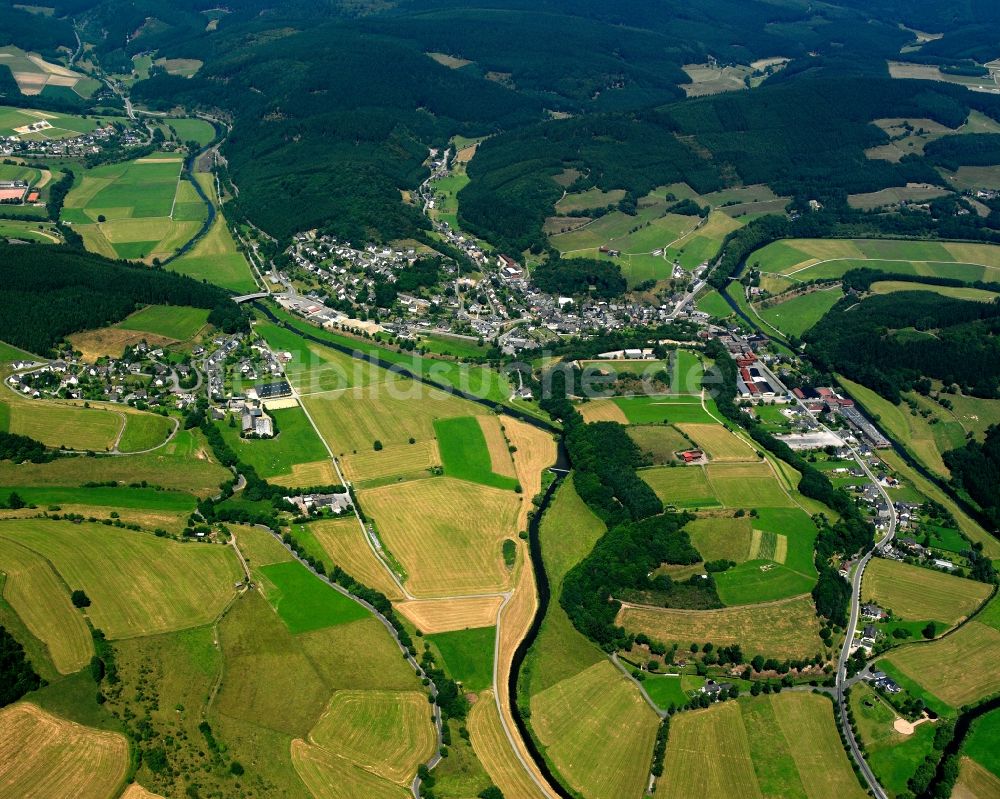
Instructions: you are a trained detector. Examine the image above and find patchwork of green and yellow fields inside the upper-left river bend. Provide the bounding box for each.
[62,153,208,263]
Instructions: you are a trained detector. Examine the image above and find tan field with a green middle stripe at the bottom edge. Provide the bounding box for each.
[655,692,865,799]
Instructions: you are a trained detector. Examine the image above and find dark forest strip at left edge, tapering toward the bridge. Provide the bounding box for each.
[0,243,246,355]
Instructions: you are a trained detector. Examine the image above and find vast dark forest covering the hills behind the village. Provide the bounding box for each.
[25,0,984,247]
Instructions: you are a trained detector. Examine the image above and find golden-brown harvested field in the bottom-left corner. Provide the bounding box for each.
[0,703,129,799]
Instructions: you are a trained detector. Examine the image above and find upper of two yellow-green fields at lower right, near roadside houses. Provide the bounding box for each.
[861,558,990,626]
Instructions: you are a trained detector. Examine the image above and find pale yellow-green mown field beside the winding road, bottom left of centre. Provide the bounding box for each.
[309,691,437,785]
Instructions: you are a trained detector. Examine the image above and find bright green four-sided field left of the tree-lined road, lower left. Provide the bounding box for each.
[259,561,368,633]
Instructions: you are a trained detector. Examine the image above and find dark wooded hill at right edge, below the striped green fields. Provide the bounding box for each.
[804,291,1000,404]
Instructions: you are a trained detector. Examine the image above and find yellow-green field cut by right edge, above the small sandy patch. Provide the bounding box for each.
[888,621,1000,708]
